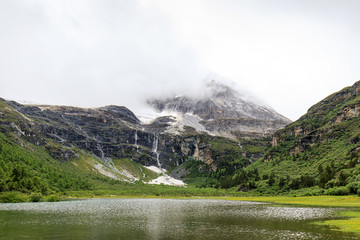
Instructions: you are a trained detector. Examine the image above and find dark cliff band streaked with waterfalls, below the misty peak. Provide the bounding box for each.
[0,100,249,174]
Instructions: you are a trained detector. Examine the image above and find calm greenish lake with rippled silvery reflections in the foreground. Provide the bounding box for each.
[0,199,359,240]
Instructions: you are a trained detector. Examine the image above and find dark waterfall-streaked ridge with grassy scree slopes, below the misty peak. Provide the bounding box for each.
[0,94,268,191]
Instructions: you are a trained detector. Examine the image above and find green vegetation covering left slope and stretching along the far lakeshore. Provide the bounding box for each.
[0,128,250,202]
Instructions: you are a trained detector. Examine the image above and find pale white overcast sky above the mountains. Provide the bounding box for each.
[0,0,360,120]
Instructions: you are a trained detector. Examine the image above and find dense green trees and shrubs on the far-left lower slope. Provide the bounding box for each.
[0,134,93,195]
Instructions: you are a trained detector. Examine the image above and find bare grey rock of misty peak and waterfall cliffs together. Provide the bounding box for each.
[0,79,290,182]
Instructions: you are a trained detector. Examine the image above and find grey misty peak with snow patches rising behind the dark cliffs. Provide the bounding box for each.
[147,80,291,139]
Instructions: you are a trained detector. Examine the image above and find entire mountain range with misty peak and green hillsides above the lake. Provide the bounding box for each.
[0,81,360,195]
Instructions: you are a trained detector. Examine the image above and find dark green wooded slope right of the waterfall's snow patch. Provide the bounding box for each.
[181,135,270,189]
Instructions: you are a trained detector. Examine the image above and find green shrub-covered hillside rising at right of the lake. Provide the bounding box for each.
[230,81,360,195]
